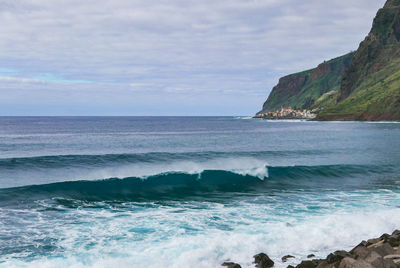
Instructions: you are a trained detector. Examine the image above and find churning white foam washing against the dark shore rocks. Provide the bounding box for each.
[0,193,400,268]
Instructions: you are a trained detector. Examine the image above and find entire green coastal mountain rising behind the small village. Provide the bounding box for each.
[260,0,400,120]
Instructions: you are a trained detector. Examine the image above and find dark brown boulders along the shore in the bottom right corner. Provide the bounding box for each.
[222,230,400,268]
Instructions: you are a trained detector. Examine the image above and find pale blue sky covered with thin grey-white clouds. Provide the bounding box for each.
[0,0,385,116]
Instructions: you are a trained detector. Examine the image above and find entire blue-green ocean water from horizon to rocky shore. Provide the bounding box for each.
[0,117,400,268]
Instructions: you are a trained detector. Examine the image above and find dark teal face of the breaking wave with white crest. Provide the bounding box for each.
[0,165,390,203]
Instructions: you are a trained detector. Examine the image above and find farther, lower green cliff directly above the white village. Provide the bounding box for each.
[262,53,354,112]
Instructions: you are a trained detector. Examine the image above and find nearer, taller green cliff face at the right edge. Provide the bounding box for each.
[318,0,400,120]
